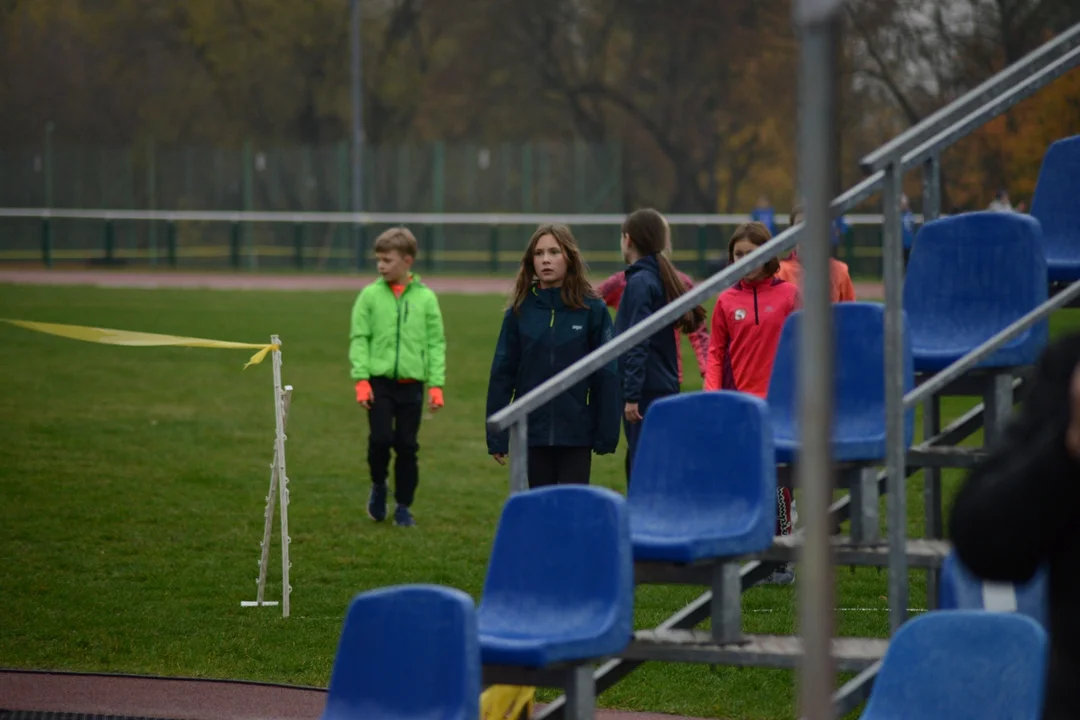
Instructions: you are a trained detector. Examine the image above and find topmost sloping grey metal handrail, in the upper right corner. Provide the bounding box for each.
[859,23,1080,173]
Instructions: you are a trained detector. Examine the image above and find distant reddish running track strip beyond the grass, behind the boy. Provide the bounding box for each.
[0,270,885,300]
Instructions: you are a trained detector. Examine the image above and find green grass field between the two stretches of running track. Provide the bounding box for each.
[0,286,1072,719]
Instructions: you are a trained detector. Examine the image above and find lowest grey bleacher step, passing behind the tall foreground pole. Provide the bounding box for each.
[620,630,889,673]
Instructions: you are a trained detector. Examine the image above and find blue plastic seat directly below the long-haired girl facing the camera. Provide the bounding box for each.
[477,486,634,668]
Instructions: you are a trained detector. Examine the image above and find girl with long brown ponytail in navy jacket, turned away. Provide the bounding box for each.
[615,208,705,488]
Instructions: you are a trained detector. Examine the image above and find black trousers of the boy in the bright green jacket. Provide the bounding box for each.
[367,378,423,507]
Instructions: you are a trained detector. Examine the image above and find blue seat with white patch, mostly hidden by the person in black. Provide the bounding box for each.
[937,552,1050,627]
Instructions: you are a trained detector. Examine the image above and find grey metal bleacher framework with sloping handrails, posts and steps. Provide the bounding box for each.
[487,15,1080,718]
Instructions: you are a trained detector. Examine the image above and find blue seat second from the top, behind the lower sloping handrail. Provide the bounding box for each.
[904,213,1050,372]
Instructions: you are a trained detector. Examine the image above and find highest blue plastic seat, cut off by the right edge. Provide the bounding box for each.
[1031,135,1080,283]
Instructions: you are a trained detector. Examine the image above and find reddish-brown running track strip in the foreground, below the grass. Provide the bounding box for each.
[0,670,721,720]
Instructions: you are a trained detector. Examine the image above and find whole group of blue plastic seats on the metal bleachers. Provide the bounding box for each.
[315,137,1080,720]
